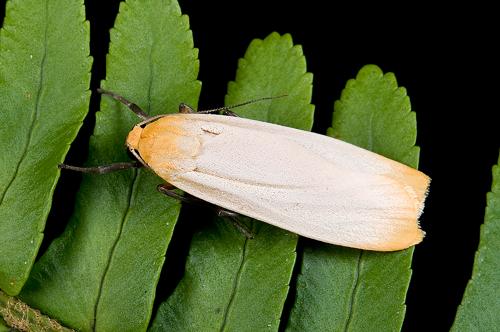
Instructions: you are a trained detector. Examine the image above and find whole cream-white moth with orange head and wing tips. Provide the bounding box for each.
[60,90,430,251]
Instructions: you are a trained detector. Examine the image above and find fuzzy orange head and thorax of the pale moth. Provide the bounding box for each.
[127,115,201,181]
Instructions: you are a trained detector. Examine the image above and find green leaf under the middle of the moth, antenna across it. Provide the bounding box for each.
[152,33,314,331]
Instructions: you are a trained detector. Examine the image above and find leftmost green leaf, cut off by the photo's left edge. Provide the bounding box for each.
[0,0,92,295]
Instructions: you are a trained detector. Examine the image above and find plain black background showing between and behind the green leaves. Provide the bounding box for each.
[1,0,500,331]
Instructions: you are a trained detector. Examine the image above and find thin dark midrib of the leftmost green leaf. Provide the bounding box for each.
[0,0,49,206]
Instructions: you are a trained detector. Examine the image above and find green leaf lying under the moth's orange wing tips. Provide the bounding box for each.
[287,65,419,331]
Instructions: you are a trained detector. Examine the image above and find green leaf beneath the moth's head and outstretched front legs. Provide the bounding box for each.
[22,0,200,331]
